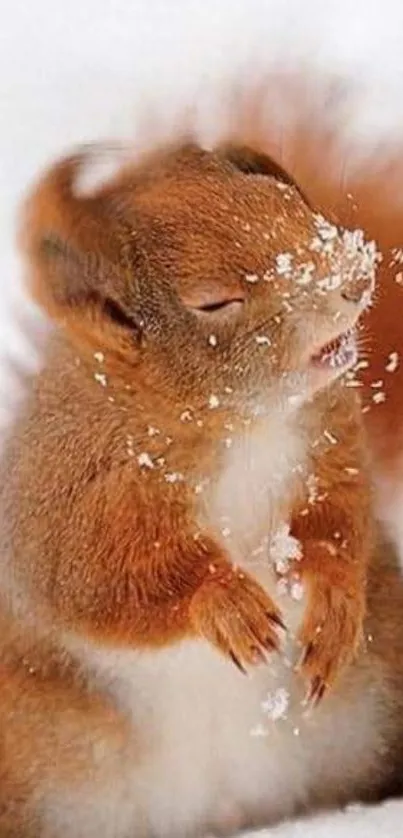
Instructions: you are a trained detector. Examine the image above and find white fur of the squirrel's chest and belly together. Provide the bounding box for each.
[48,421,382,838]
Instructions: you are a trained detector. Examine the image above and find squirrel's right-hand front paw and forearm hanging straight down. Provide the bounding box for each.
[298,541,365,704]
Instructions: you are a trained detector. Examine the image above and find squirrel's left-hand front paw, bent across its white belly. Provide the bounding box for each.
[190,565,284,672]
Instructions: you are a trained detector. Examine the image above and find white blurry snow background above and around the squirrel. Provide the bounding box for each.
[0,0,403,838]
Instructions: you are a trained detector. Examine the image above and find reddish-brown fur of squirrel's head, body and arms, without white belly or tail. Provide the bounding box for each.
[0,108,403,838]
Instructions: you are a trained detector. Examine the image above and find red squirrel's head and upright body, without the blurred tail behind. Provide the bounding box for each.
[0,135,403,838]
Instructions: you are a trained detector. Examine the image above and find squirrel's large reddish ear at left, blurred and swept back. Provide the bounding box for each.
[20,147,145,350]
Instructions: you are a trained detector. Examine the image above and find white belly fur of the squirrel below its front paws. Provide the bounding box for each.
[54,624,379,838]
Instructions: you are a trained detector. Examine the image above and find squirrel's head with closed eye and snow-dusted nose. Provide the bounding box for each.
[22,144,377,424]
